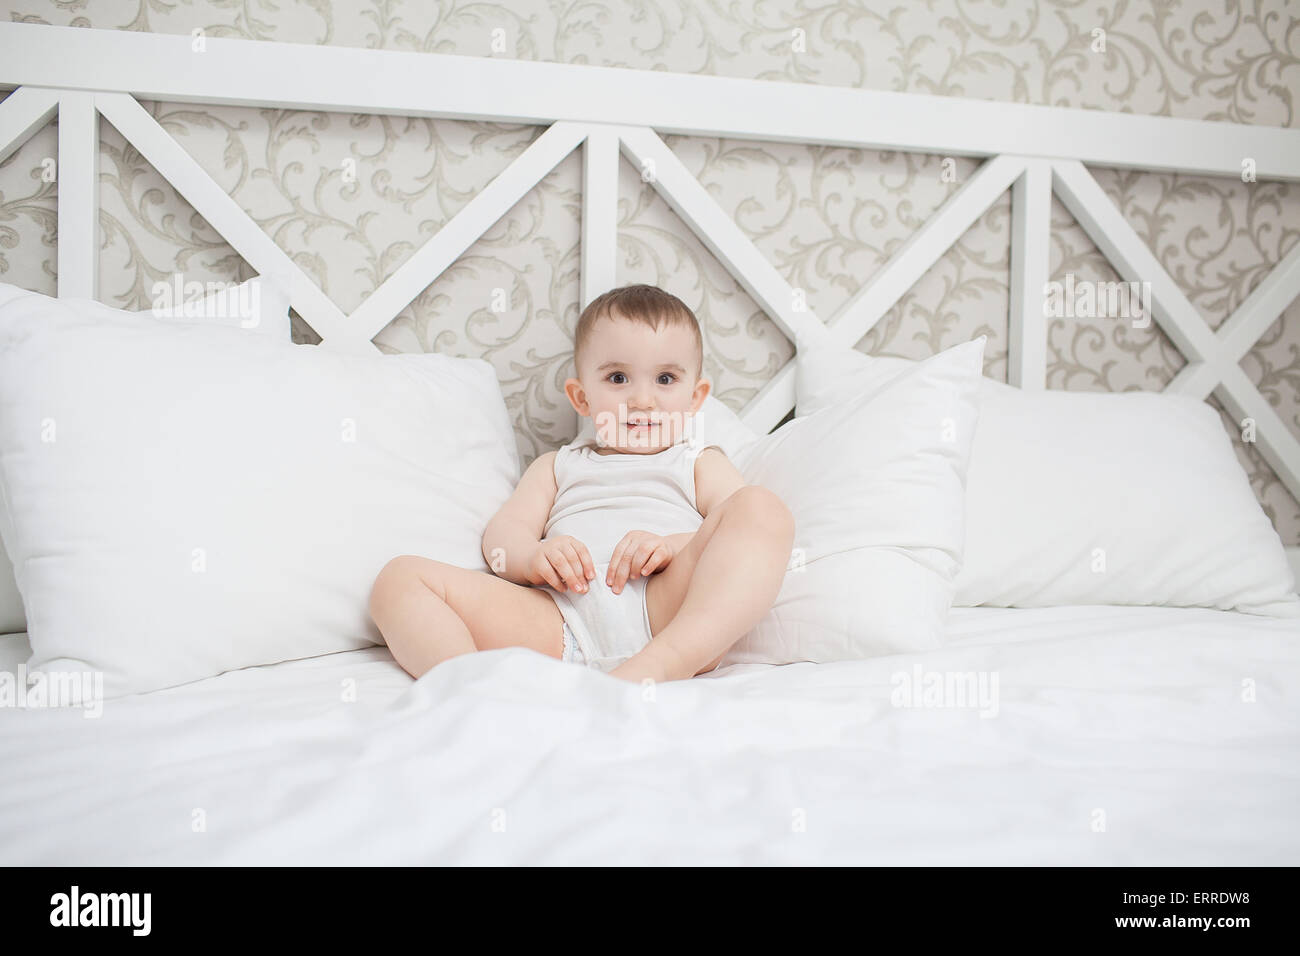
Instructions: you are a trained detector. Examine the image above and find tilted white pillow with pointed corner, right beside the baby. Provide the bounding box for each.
[723,336,985,666]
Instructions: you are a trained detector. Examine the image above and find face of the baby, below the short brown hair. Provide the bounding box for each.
[564,317,710,454]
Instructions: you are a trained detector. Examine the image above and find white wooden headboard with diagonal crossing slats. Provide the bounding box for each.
[0,23,1300,509]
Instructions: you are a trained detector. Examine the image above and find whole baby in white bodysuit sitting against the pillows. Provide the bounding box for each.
[369,285,794,682]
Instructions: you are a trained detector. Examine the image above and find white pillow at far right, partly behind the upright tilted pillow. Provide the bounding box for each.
[798,349,1300,618]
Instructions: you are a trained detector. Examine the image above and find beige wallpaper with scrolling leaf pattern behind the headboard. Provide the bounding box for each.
[0,0,1300,544]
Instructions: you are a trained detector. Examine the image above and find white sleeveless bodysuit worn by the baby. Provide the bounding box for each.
[541,438,709,671]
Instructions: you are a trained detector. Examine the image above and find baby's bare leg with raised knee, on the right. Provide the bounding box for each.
[639,485,794,679]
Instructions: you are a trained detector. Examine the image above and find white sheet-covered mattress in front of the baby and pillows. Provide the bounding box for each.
[0,607,1300,866]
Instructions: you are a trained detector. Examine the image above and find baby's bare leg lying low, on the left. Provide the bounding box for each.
[371,554,564,678]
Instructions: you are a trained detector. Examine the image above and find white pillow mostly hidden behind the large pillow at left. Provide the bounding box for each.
[0,276,291,633]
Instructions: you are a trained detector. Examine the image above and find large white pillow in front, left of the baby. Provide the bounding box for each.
[0,287,519,697]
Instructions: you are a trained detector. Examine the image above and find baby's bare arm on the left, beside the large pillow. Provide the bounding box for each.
[482,451,595,591]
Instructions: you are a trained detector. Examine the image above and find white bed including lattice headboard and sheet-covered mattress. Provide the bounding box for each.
[0,23,1300,865]
